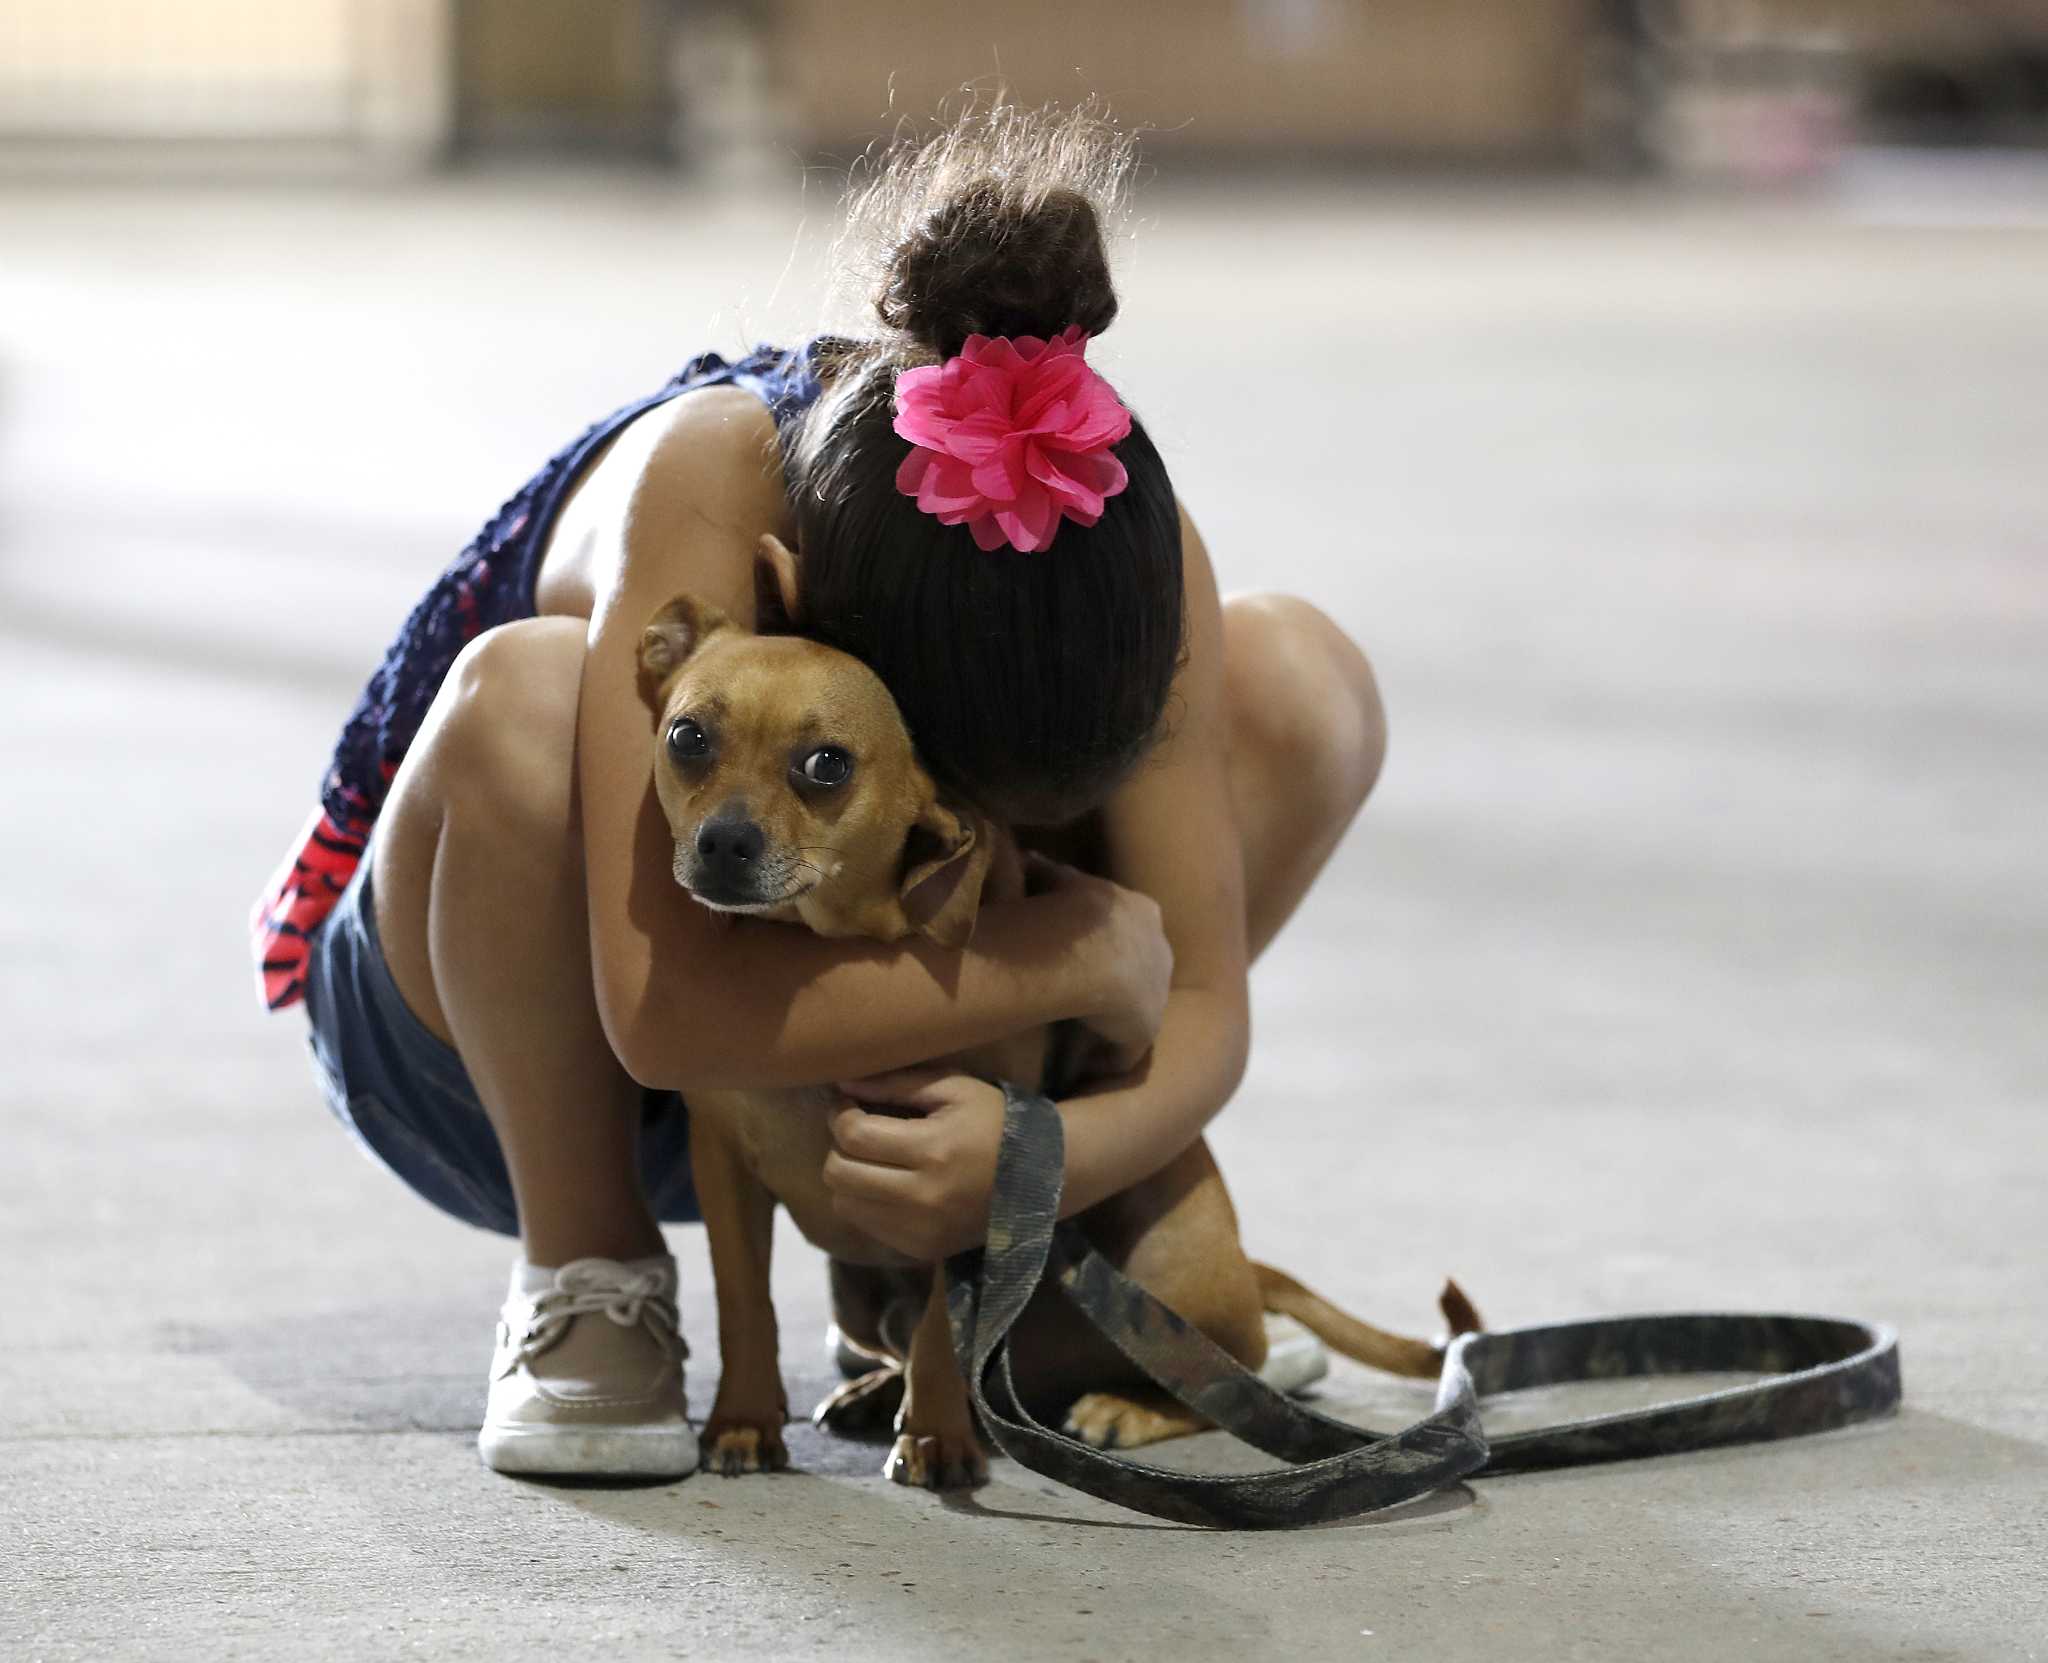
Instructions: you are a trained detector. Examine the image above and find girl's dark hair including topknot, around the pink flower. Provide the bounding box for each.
[788,104,1184,823]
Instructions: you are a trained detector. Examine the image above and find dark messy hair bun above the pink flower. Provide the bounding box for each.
[874,178,1116,358]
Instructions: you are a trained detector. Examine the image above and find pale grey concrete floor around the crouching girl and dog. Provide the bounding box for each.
[0,158,2048,1663]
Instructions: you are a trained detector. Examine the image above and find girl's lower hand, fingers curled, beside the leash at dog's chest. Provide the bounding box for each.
[825,1069,1004,1264]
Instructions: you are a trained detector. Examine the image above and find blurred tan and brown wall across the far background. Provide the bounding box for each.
[12,0,2048,178]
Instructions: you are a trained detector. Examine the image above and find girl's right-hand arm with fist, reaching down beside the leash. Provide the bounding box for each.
[825,514,1251,1260]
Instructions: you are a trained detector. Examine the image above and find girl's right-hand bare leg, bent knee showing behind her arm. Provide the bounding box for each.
[1223,594,1386,958]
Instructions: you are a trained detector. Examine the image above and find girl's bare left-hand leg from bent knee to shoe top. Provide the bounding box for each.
[371,619,664,1266]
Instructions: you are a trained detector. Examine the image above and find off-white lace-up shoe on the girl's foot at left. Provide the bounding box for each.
[477,1253,696,1479]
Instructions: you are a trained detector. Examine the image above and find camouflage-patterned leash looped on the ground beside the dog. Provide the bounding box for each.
[946,1085,1898,1530]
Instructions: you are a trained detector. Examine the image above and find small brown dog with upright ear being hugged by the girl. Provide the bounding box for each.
[639,596,1477,1489]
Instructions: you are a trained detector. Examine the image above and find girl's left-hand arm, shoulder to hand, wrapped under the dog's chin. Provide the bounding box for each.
[577,389,1169,1092]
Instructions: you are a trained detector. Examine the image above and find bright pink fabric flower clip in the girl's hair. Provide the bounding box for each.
[895,328,1130,555]
